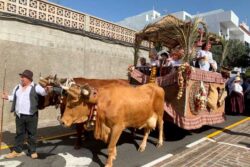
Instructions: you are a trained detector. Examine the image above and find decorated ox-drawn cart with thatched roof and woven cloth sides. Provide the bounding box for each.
[129,16,226,130]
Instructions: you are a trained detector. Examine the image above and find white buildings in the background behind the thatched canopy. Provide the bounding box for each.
[118,9,250,46]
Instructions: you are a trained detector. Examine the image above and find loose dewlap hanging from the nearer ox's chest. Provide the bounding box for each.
[94,112,110,143]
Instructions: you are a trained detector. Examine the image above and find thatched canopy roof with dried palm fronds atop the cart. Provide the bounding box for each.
[135,15,222,64]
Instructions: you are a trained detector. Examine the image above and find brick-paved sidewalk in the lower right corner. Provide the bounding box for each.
[154,117,250,167]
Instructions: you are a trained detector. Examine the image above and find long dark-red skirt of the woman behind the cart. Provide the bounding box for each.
[230,91,245,113]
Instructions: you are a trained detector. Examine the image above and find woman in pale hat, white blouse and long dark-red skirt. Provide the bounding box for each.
[229,76,245,114]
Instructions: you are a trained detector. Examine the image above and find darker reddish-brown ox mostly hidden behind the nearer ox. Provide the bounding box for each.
[40,76,129,149]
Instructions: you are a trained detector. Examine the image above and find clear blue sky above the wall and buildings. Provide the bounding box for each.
[49,0,250,25]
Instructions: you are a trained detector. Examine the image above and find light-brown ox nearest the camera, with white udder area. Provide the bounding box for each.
[62,84,165,166]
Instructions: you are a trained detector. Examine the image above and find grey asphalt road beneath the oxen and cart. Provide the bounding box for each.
[0,116,245,167]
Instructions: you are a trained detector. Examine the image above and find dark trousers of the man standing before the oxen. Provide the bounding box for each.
[13,112,38,154]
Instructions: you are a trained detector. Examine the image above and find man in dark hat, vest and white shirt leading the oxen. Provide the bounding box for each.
[2,70,47,159]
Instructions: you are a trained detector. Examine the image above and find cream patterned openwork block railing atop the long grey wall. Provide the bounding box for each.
[0,0,147,46]
